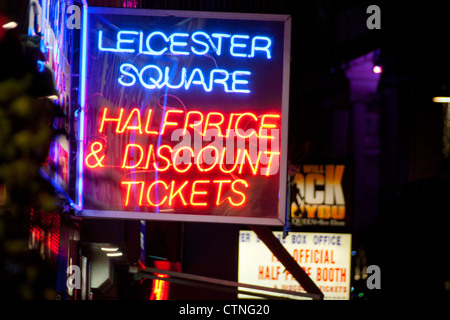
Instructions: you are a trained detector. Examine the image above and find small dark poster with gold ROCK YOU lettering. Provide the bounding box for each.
[291,164,349,227]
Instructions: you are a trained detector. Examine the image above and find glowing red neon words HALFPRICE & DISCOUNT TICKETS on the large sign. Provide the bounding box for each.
[92,106,281,214]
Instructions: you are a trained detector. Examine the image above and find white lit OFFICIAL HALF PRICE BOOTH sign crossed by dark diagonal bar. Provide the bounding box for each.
[238,230,352,300]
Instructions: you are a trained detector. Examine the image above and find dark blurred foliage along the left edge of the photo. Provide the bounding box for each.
[0,73,57,300]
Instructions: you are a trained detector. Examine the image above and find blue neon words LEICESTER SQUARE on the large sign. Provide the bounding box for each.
[98,30,273,94]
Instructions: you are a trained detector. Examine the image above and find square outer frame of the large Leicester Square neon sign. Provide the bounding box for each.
[73,6,291,226]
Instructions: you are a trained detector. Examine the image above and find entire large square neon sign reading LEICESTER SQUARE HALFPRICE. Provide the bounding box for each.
[77,8,290,225]
